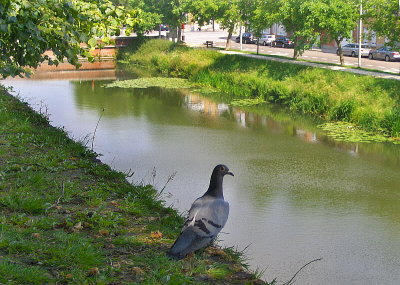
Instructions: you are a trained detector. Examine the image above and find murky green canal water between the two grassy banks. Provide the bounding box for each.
[5,72,400,285]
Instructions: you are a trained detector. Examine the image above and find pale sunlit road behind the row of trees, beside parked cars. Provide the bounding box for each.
[184,31,400,73]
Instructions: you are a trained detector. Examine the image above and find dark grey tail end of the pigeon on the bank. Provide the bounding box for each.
[167,227,212,260]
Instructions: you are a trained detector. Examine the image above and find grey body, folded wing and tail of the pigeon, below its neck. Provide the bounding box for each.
[168,197,229,259]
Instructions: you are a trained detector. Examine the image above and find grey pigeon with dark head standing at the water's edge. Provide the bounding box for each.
[167,164,233,260]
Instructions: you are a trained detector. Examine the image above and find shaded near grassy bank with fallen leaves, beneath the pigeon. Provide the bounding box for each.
[0,89,268,284]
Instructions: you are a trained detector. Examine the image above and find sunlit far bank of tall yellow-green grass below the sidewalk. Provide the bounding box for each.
[119,40,400,137]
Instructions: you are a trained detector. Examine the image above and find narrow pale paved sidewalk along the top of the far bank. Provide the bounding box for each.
[220,50,400,80]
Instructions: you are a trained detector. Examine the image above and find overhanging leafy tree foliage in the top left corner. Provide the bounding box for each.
[0,0,140,77]
